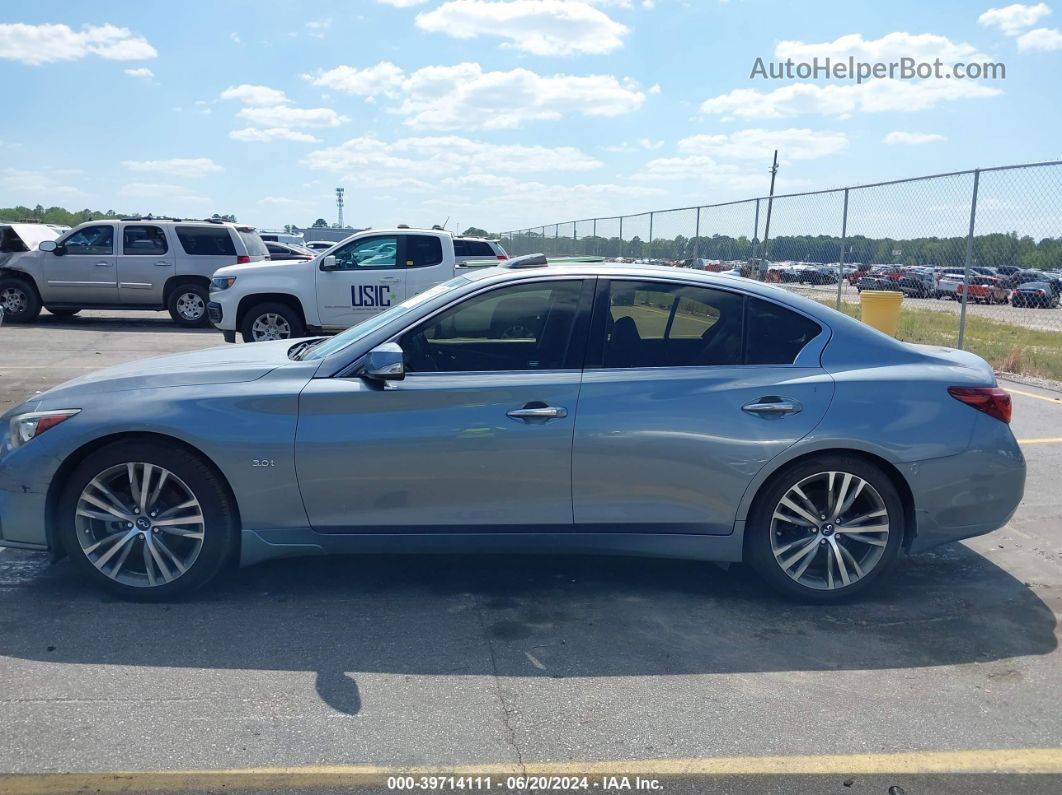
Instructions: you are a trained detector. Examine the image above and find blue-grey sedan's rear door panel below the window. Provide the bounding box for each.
[572,366,834,534]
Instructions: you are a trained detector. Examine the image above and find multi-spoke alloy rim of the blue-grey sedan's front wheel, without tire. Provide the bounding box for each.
[74,462,206,588]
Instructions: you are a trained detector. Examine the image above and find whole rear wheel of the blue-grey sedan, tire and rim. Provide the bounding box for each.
[746,455,904,604]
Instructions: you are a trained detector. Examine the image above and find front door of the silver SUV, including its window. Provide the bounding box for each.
[41,224,118,307]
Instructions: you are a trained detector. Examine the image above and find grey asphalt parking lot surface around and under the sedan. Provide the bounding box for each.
[0,312,1062,793]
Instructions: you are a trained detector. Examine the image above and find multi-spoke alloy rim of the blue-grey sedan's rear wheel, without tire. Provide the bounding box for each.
[771,471,889,590]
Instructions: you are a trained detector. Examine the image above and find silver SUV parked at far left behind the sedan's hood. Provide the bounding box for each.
[0,217,269,326]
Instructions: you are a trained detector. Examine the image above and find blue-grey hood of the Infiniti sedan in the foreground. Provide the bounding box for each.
[29,340,310,400]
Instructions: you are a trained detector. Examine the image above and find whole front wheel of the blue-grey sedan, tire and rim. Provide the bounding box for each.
[58,442,238,601]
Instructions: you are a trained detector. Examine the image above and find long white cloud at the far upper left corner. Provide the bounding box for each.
[0,22,158,66]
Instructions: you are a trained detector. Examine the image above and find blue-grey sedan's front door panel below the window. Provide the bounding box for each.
[295,371,579,533]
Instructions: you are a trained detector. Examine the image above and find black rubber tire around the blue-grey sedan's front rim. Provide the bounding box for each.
[56,440,239,602]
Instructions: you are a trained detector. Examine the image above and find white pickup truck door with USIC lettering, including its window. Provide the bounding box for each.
[316,235,407,328]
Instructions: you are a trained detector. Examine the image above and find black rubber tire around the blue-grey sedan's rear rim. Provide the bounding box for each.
[744,454,905,604]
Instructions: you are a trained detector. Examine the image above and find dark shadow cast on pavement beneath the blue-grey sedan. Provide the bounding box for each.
[0,545,1057,714]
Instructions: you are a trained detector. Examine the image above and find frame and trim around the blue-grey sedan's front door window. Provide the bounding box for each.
[367,274,600,378]
